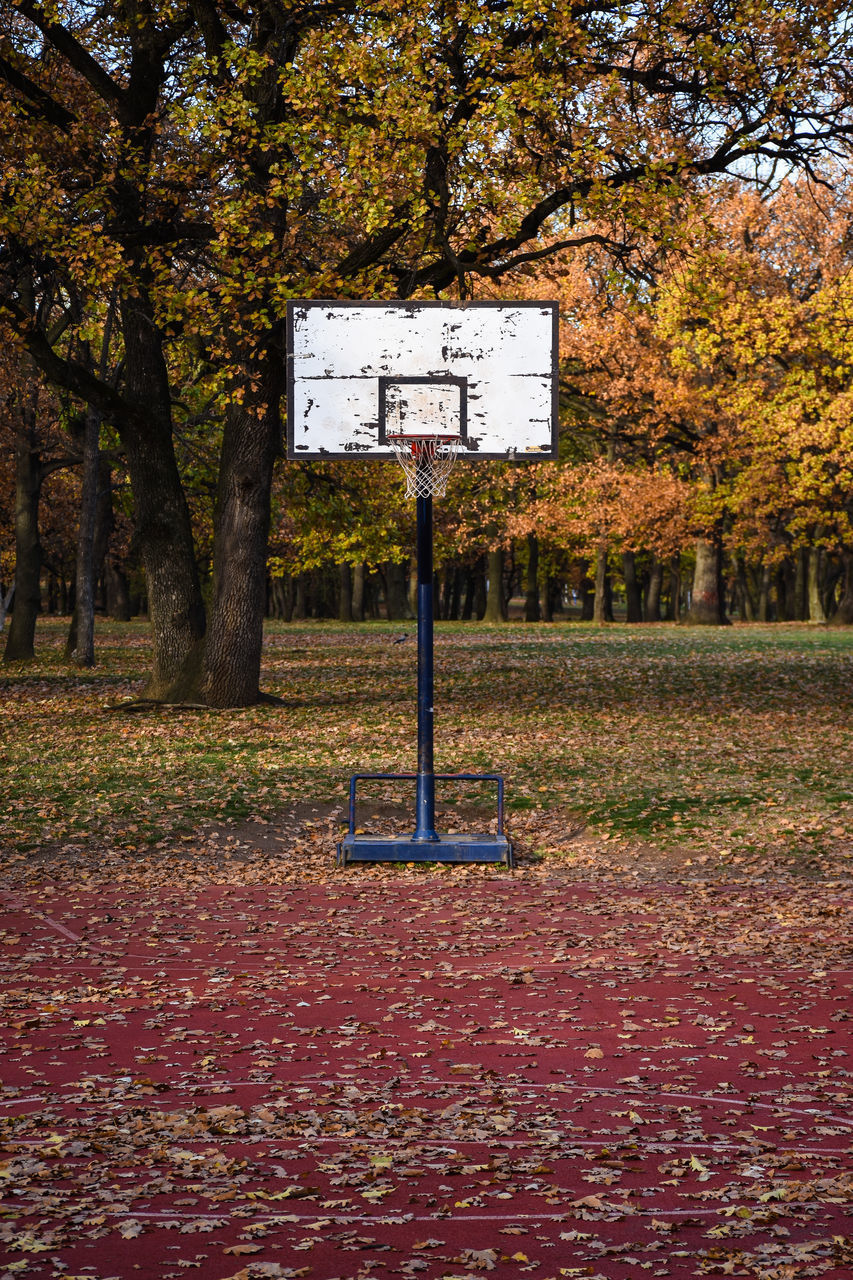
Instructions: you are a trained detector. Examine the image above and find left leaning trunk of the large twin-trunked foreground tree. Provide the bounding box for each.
[118,293,205,701]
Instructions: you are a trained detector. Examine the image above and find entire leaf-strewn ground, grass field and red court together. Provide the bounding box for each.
[0,621,853,1280]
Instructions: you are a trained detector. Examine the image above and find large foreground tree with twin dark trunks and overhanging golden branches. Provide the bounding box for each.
[0,0,849,704]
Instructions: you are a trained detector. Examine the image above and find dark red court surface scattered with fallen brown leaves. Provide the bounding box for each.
[0,868,853,1280]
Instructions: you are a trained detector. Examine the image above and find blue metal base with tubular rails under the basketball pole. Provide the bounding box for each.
[336,773,515,868]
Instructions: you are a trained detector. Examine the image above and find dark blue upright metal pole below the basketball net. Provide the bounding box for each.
[411,495,439,842]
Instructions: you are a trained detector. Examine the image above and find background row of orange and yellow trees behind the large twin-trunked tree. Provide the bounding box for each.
[0,175,853,640]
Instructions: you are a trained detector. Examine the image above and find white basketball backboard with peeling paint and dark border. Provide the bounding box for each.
[287,301,557,460]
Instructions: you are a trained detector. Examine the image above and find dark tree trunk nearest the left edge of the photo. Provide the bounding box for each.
[3,397,42,662]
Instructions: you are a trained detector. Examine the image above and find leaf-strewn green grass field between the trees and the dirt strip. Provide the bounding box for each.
[0,620,853,870]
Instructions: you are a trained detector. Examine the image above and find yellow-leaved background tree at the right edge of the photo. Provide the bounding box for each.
[661,179,853,622]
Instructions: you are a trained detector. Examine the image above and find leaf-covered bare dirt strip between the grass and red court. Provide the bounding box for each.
[0,801,853,884]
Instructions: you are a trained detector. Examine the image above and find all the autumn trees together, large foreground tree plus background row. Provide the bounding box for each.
[0,0,853,705]
